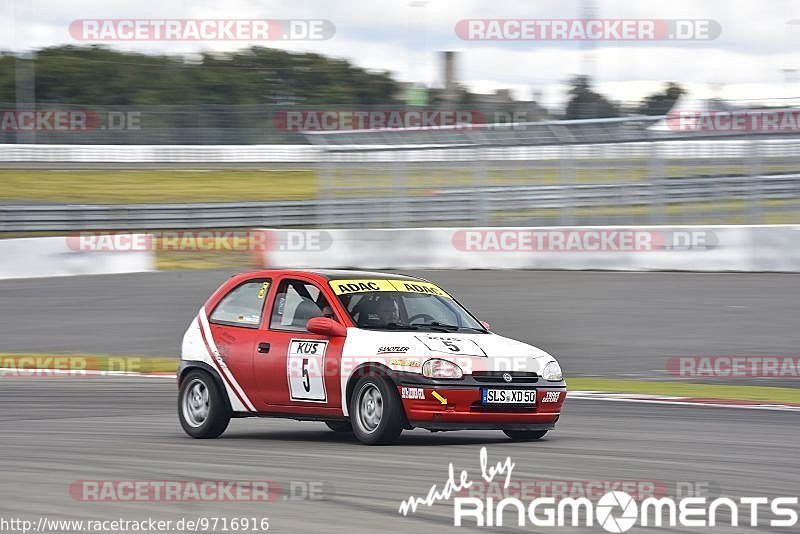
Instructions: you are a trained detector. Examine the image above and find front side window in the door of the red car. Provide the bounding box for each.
[269,280,333,332]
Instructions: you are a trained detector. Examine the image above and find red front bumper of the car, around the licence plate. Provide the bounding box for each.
[398,382,567,430]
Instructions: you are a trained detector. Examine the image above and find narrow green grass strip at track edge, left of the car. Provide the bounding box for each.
[0,352,178,374]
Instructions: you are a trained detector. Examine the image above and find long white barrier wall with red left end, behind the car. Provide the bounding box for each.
[253,225,800,272]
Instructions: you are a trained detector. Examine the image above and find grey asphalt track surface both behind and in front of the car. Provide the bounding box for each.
[0,271,800,533]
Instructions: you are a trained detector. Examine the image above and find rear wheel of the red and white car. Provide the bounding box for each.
[178,369,231,439]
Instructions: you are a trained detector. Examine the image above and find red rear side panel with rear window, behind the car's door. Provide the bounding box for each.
[208,278,271,404]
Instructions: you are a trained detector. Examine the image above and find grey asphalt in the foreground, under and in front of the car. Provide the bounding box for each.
[0,377,800,533]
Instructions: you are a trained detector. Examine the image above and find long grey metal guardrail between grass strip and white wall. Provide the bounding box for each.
[0,174,800,232]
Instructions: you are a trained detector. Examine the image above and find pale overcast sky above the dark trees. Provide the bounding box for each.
[0,0,800,109]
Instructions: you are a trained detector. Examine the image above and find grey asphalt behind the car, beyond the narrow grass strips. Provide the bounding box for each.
[0,271,800,387]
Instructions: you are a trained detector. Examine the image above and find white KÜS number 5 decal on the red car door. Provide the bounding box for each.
[286,339,328,402]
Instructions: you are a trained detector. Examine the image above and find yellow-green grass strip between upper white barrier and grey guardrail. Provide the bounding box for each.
[0,158,797,204]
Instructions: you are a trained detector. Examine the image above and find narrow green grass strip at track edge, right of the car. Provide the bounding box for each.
[567,377,800,404]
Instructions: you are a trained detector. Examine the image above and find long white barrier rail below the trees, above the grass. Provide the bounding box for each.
[0,135,800,164]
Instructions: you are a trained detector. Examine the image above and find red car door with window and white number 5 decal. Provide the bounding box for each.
[254,277,344,414]
